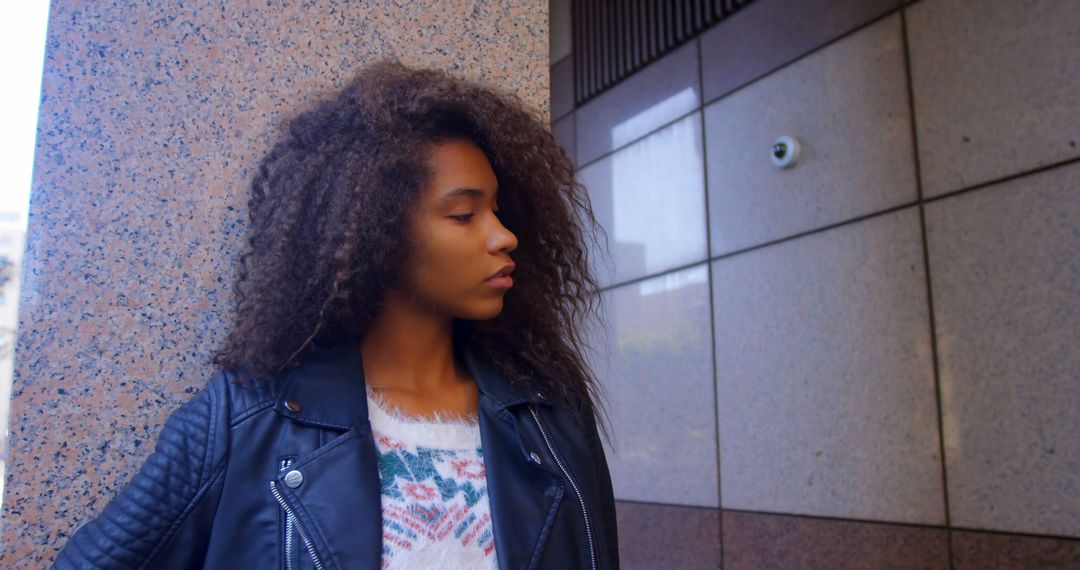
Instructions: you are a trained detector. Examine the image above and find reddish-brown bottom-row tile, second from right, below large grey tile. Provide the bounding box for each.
[713,511,949,570]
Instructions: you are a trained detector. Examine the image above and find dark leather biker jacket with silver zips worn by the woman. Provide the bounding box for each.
[54,344,619,570]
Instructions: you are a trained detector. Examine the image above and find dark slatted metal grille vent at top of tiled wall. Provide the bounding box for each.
[573,0,753,106]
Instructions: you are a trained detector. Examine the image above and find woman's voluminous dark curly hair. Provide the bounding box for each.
[214,60,603,425]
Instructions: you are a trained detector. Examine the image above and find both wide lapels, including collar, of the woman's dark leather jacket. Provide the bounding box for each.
[275,343,566,570]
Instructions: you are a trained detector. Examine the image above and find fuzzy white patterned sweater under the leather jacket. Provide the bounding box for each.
[367,389,498,570]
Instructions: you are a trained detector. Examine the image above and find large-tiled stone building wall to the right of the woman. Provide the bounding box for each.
[551,0,1080,569]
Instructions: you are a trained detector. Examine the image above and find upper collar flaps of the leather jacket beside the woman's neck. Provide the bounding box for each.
[274,341,545,430]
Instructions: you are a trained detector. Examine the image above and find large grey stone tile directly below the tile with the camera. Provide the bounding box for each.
[713,208,944,524]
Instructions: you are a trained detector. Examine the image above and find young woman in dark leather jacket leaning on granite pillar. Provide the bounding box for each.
[55,57,618,570]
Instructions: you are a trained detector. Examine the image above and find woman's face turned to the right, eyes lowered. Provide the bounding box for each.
[403,139,517,320]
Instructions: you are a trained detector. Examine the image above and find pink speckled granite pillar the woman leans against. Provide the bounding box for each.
[0,0,549,568]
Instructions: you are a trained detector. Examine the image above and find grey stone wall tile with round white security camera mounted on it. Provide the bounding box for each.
[705,13,917,256]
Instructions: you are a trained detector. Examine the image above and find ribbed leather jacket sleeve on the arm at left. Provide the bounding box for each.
[53,371,229,570]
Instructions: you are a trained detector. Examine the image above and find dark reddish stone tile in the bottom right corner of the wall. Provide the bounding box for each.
[953,530,1080,570]
